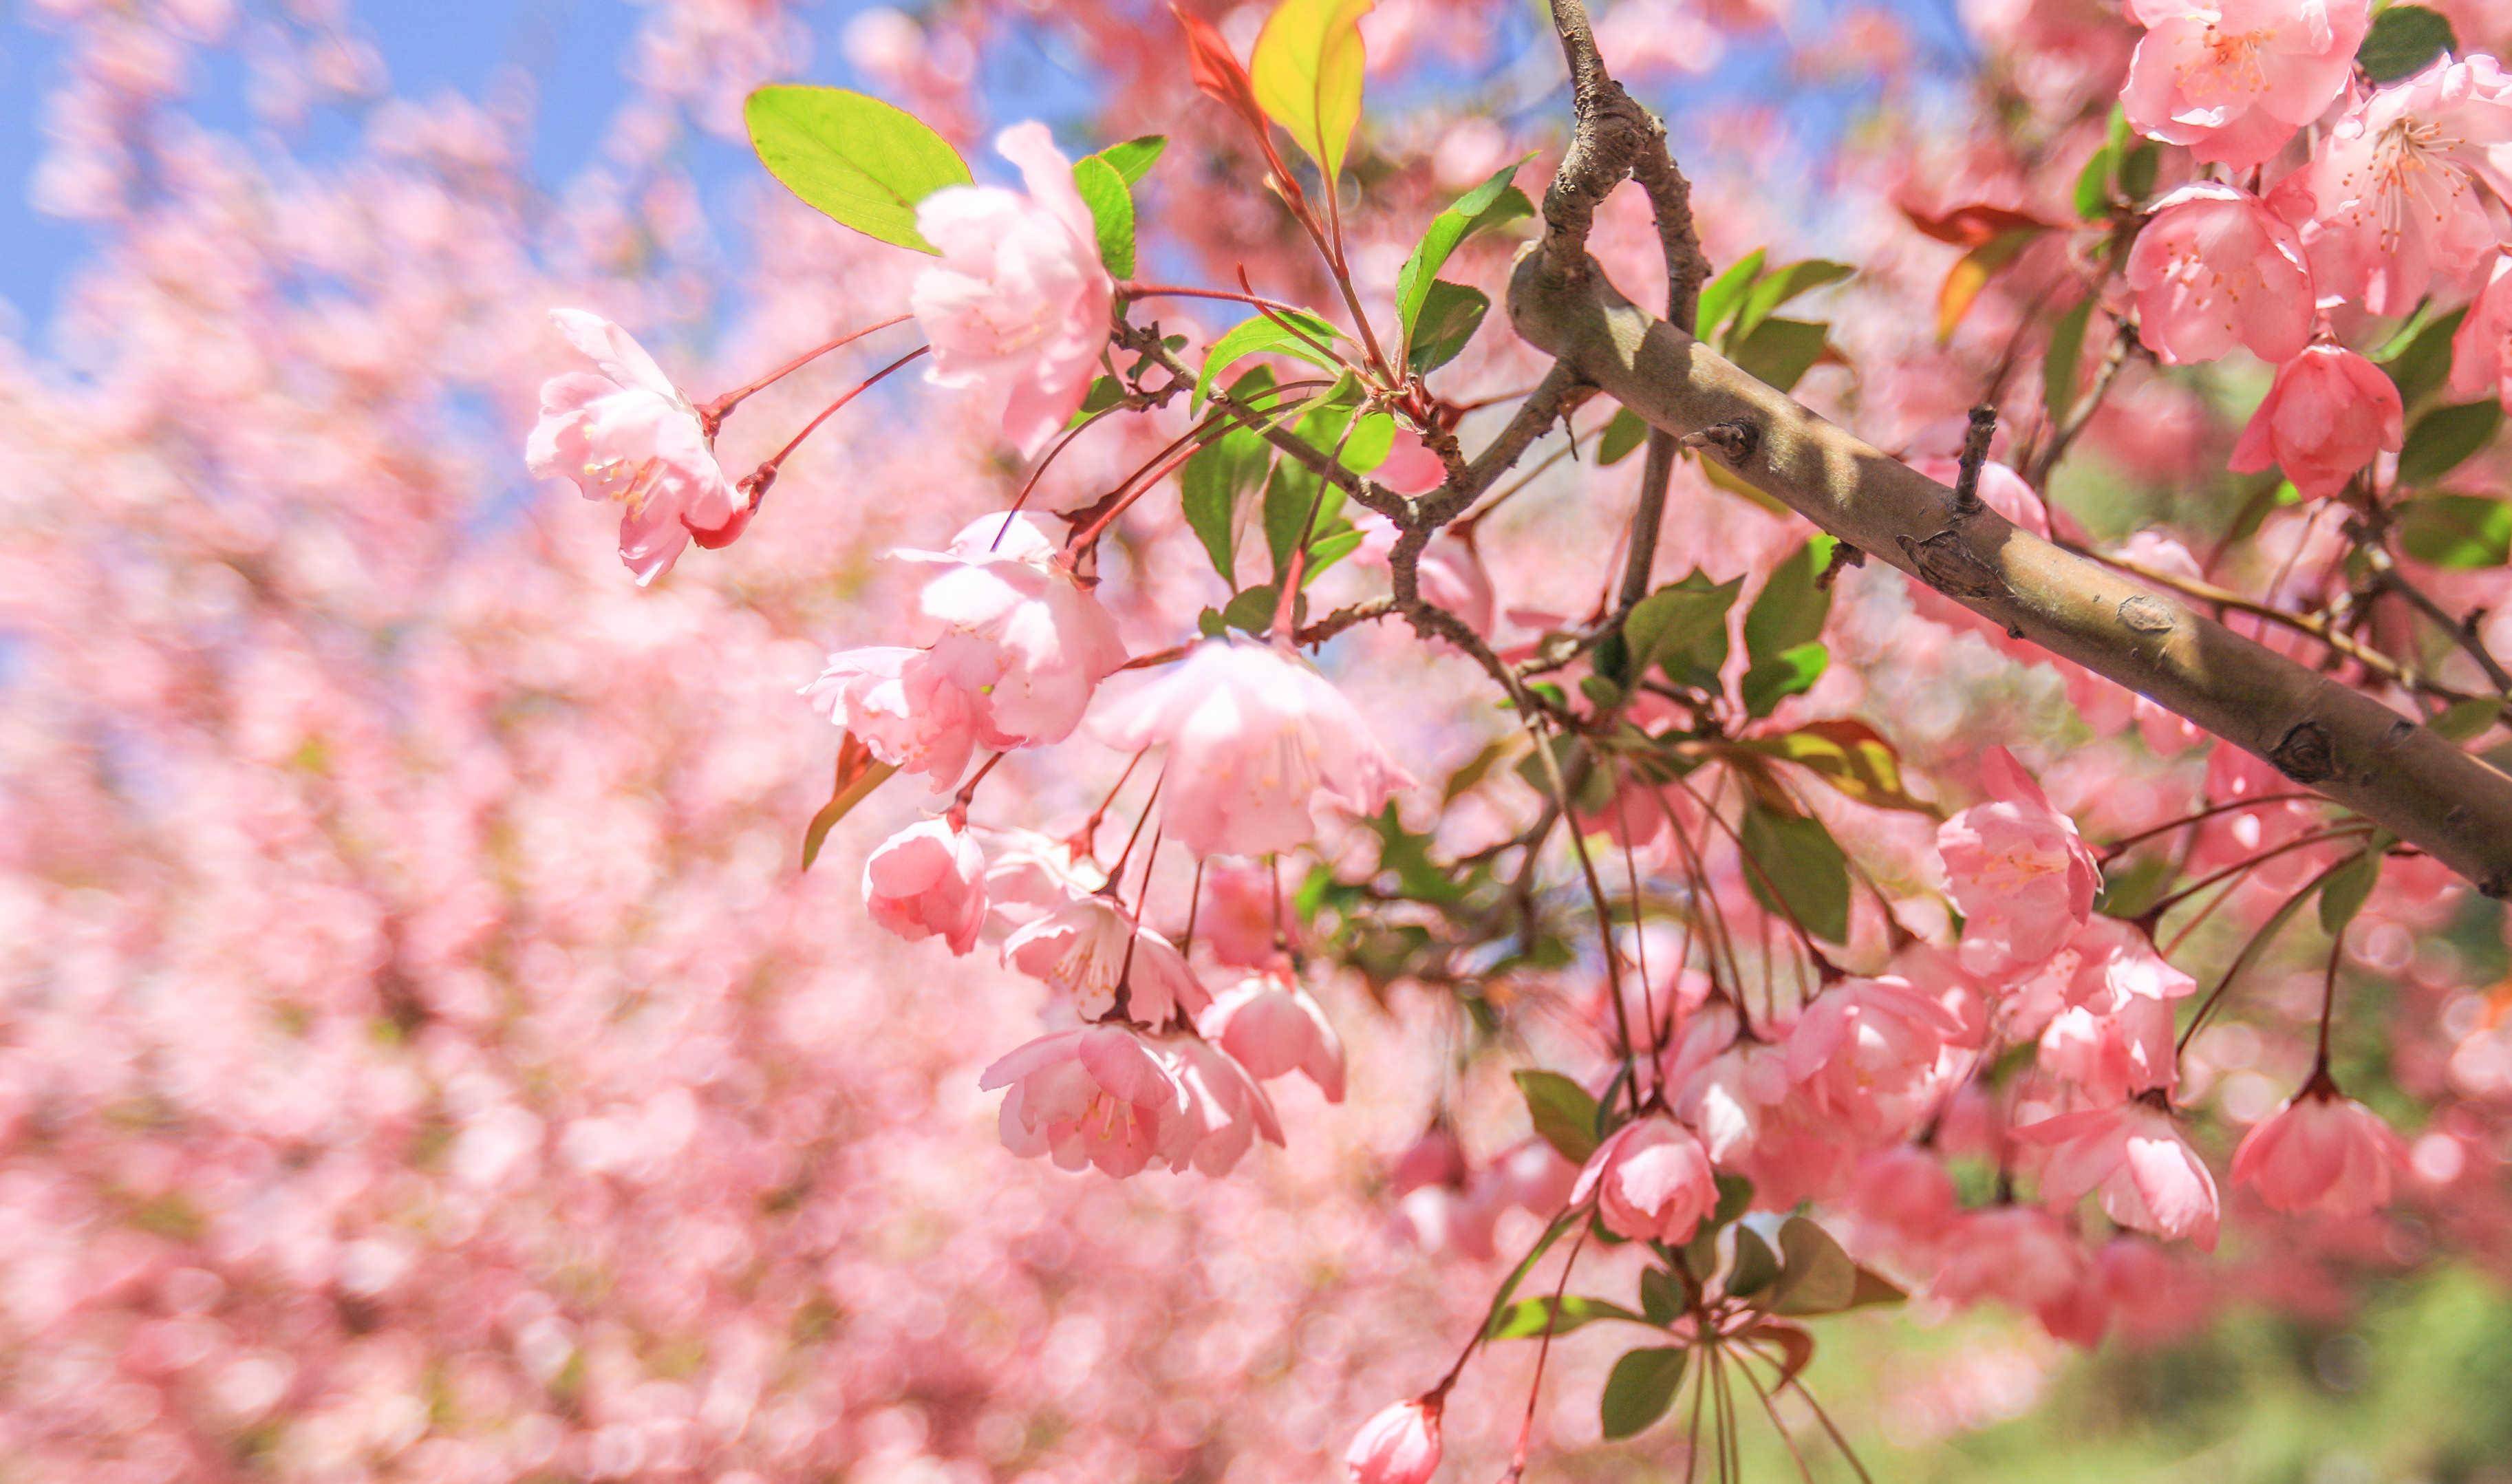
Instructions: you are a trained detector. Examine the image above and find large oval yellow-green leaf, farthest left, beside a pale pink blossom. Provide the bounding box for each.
[741,83,969,254]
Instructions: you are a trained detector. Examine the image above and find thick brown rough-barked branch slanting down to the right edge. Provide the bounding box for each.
[1510,244,2512,896]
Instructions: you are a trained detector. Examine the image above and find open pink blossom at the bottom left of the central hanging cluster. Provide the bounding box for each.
[977,1024,1201,1178]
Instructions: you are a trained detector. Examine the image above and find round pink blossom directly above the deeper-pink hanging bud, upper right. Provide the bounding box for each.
[2127,181,2314,367]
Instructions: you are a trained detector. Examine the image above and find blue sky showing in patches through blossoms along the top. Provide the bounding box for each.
[0,0,1967,336]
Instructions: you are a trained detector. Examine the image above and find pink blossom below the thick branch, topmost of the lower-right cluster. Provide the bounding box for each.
[1937,749,2103,979]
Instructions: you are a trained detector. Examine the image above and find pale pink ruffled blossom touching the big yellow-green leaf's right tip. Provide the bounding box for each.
[907,123,1115,455]
